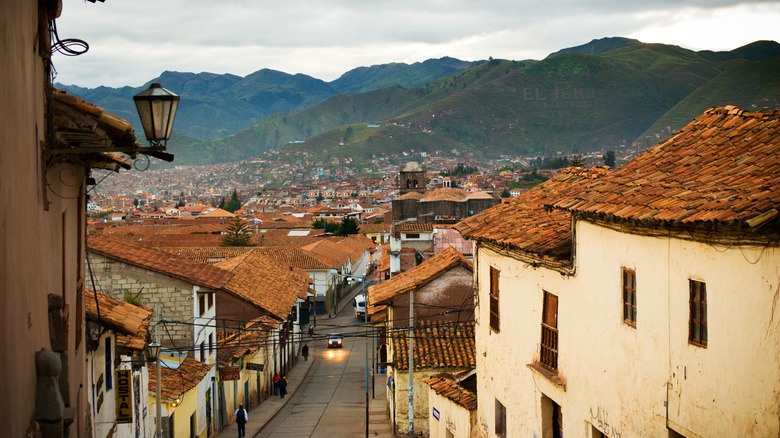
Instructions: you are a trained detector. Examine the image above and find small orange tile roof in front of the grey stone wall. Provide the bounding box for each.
[84,290,152,350]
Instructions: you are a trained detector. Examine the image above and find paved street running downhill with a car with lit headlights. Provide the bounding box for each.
[255,286,394,438]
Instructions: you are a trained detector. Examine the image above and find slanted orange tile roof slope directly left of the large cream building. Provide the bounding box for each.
[368,246,474,314]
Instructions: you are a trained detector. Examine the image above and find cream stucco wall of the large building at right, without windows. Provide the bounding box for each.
[476,222,780,437]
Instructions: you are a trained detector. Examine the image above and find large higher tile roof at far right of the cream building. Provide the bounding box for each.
[552,106,780,226]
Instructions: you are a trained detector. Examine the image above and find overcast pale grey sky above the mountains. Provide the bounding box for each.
[54,0,780,88]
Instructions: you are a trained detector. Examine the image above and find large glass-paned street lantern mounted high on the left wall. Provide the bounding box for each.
[133,82,179,149]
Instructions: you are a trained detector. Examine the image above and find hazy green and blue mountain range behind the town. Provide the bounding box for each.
[55,38,780,164]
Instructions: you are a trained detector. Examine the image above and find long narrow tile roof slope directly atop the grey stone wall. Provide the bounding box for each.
[87,233,232,289]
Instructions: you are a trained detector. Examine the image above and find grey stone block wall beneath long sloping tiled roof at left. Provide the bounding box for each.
[88,252,195,348]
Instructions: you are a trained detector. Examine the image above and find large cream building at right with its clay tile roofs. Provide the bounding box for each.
[457,107,780,437]
